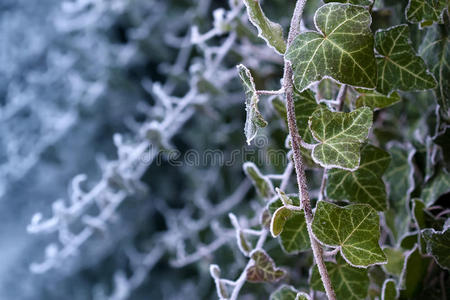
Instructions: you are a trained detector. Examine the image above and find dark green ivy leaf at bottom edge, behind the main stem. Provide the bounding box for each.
[310,256,369,300]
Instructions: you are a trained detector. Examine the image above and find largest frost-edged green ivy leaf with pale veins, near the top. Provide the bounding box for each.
[285,3,377,91]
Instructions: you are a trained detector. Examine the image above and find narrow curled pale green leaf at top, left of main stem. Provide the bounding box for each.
[244,0,286,54]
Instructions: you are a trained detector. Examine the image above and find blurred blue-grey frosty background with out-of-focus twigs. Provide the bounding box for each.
[0,0,298,300]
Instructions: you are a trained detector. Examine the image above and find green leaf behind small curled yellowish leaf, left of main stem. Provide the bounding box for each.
[269,197,311,254]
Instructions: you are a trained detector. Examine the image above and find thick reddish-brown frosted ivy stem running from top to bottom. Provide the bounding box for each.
[283,0,336,300]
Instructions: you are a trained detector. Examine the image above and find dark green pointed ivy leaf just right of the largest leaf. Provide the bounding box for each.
[375,25,436,95]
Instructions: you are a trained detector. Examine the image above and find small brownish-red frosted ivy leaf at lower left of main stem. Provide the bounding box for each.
[247,250,286,282]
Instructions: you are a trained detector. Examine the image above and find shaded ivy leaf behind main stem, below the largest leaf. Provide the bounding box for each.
[272,90,320,144]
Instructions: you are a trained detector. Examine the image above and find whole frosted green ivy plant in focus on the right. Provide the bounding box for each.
[214,0,450,300]
